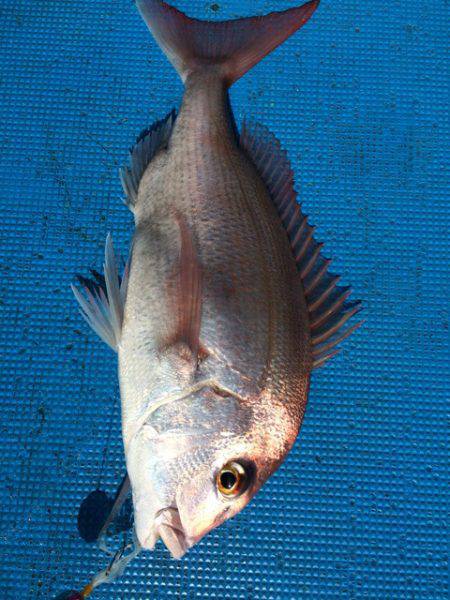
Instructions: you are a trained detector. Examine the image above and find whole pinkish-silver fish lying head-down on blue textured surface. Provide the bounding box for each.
[73,0,362,558]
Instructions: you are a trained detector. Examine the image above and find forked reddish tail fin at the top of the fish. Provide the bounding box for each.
[136,0,319,85]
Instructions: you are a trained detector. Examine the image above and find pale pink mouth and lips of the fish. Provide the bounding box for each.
[142,507,200,559]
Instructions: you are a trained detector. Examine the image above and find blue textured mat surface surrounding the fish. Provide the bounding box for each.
[0,0,450,600]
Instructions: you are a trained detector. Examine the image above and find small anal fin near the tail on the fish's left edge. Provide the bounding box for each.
[119,109,177,210]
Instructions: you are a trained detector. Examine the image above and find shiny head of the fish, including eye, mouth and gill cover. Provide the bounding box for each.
[127,387,296,558]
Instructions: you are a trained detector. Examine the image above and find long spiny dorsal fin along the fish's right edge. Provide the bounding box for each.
[240,122,363,367]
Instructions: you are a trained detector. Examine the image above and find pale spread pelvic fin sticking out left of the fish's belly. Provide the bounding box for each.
[71,234,129,352]
